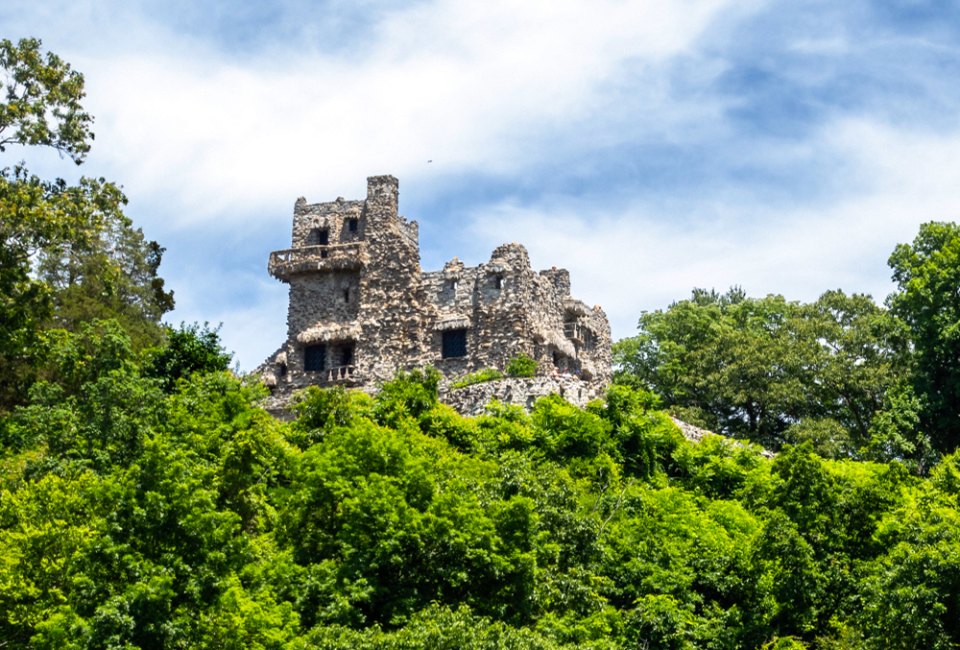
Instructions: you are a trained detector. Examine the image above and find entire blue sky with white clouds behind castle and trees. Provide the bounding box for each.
[0,0,960,370]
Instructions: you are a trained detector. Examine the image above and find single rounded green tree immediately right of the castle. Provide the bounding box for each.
[615,289,815,445]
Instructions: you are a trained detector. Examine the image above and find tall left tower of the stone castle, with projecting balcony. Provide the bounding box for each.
[268,176,421,389]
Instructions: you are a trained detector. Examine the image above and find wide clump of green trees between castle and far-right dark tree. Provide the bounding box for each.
[614,288,907,455]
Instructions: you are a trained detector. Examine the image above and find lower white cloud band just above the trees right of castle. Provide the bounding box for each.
[472,121,960,338]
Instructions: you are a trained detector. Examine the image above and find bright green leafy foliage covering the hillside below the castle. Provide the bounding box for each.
[0,350,960,648]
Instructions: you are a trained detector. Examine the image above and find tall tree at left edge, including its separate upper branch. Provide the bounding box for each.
[0,39,173,410]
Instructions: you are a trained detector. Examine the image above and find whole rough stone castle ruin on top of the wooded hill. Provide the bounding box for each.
[258,176,611,401]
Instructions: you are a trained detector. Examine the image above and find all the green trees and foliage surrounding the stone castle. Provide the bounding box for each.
[0,39,960,649]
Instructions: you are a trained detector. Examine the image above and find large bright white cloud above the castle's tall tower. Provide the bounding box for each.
[65,0,734,220]
